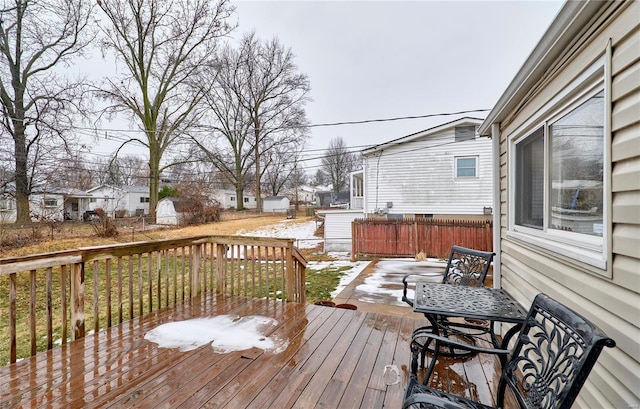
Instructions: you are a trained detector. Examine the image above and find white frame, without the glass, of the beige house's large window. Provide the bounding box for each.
[507,56,611,277]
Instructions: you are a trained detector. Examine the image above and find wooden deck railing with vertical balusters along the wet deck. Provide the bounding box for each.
[0,236,306,366]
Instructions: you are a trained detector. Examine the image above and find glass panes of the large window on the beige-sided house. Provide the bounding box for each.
[514,91,604,237]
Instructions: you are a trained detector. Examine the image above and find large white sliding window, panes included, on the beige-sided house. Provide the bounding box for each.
[510,82,608,269]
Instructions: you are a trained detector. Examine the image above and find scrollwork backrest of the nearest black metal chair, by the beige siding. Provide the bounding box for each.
[498,294,616,409]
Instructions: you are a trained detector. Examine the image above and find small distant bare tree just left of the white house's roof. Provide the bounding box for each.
[322,136,361,197]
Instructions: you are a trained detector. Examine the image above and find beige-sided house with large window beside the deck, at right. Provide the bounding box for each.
[480,1,640,408]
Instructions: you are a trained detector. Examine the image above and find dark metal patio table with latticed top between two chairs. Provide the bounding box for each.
[413,283,527,349]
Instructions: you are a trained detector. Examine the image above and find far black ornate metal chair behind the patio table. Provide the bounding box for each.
[402,246,495,367]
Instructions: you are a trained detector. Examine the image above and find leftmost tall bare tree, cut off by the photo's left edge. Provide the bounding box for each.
[0,0,93,224]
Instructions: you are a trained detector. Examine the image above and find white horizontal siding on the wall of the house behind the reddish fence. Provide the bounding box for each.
[364,122,493,215]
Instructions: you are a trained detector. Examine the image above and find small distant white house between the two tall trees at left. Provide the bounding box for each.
[87,185,149,217]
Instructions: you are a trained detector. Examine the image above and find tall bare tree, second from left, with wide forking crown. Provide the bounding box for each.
[98,0,233,217]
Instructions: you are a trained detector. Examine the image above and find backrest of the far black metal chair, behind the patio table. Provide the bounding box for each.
[442,246,495,287]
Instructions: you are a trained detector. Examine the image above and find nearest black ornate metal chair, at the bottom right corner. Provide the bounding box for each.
[402,294,615,409]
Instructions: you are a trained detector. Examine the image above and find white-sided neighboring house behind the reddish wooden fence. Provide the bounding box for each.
[350,118,493,220]
